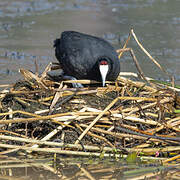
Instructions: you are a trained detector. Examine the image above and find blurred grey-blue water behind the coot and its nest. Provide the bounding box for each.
[0,0,180,84]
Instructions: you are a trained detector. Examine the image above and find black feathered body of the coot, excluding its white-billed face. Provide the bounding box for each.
[54,31,120,81]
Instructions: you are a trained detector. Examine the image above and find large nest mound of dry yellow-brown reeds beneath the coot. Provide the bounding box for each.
[0,30,180,162]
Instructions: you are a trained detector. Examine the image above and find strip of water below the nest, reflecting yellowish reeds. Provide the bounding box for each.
[0,158,180,180]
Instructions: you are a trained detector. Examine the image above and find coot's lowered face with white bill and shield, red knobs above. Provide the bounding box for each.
[99,57,111,87]
